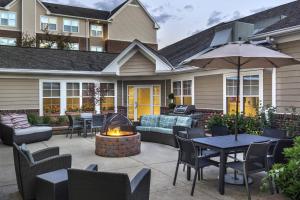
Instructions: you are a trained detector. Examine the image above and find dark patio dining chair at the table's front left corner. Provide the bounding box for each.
[173,135,218,196]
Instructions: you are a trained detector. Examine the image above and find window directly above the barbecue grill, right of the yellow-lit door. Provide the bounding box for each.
[173,80,192,105]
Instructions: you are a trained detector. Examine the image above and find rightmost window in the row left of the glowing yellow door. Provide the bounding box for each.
[100,83,115,111]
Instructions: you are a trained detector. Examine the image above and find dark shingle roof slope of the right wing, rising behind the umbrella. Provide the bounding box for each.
[159,0,300,67]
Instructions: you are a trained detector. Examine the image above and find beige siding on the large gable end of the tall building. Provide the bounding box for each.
[108,5,157,44]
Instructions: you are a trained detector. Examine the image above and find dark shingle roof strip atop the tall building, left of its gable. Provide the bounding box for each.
[43,2,110,20]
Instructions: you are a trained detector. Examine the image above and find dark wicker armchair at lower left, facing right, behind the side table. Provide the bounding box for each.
[13,143,72,200]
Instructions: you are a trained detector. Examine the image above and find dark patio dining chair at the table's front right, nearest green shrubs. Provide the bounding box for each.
[227,142,273,200]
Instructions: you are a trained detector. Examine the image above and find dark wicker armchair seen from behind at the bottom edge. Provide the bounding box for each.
[68,166,151,200]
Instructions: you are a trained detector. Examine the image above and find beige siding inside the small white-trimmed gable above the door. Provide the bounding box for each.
[120,51,155,76]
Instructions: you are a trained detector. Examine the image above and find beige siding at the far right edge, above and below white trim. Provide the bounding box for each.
[277,41,300,112]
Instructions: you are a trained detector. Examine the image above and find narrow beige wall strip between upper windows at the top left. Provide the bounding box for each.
[22,0,36,35]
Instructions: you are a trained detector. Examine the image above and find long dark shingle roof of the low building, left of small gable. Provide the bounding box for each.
[0,46,117,72]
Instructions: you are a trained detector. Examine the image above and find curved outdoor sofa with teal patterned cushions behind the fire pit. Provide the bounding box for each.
[136,115,197,147]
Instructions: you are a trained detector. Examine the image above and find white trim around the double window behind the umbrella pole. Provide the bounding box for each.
[223,69,264,114]
